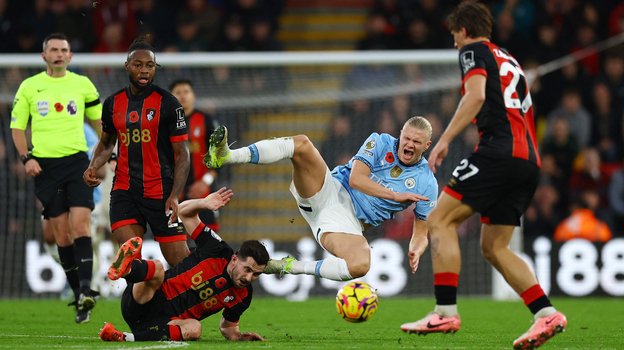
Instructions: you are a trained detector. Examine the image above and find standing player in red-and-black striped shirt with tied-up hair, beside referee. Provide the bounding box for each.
[85,40,190,266]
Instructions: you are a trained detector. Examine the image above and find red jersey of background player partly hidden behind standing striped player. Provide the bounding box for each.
[183,110,219,198]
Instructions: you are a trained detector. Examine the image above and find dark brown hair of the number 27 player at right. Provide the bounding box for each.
[446,2,494,39]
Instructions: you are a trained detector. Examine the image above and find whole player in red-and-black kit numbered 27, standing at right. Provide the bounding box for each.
[401,2,567,349]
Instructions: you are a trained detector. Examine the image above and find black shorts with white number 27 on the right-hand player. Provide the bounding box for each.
[444,153,540,226]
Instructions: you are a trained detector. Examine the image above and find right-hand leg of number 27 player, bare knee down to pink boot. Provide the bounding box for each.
[481,224,568,349]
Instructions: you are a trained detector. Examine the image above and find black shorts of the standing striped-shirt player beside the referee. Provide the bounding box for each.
[109,190,187,243]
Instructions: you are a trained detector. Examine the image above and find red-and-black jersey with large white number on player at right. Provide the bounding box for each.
[459,41,541,166]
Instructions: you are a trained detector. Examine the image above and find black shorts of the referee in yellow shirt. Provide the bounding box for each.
[35,152,95,218]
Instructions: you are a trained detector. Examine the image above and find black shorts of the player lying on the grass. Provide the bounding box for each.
[121,283,171,333]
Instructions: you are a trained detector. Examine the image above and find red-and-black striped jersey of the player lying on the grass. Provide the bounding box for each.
[160,223,253,322]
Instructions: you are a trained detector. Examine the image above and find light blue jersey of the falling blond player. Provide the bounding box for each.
[332,133,438,226]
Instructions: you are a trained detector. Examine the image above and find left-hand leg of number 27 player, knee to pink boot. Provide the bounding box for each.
[401,192,474,334]
